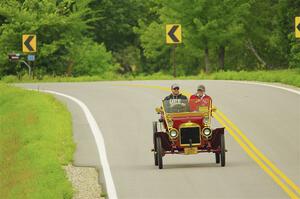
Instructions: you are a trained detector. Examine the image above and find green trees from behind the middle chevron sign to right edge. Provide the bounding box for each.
[139,0,300,73]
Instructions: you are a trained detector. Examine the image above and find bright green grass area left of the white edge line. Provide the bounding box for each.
[0,83,75,199]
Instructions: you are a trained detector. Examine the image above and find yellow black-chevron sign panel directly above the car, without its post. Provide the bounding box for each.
[166,24,182,44]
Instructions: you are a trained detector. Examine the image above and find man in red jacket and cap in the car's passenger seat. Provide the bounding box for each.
[190,85,212,112]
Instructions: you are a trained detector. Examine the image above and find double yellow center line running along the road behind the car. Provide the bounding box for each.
[115,84,300,199]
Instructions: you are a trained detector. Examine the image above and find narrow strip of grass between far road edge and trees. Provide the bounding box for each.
[1,69,300,87]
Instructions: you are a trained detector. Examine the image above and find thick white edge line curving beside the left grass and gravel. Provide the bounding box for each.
[35,90,118,199]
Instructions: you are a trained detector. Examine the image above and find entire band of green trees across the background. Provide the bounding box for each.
[0,0,300,78]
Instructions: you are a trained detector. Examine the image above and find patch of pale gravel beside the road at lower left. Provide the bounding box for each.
[64,165,104,199]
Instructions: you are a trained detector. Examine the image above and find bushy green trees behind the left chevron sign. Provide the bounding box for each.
[0,0,114,76]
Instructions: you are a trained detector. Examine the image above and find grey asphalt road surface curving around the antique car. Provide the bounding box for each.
[22,81,300,199]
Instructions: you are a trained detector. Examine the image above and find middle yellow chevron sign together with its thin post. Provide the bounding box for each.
[166,24,182,77]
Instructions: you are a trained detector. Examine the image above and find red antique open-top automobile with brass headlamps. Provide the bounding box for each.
[152,99,226,169]
